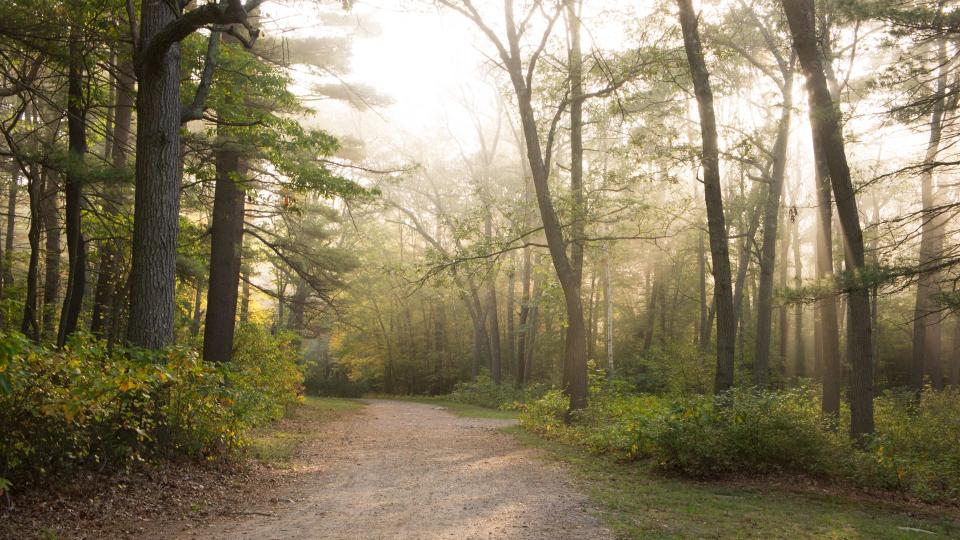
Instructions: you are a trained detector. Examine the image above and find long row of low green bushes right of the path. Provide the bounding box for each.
[520,387,960,501]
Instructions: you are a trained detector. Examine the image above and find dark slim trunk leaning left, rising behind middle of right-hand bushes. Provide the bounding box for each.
[677,0,736,393]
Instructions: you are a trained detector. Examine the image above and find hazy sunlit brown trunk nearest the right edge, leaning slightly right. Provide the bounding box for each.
[910,40,950,396]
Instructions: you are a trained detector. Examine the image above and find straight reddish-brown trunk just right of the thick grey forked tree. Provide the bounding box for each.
[203,146,246,362]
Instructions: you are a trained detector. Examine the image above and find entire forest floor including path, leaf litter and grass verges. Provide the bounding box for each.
[9,398,960,540]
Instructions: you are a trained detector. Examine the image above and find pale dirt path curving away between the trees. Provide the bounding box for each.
[180,400,612,539]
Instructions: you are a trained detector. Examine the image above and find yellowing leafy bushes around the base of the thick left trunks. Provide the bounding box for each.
[0,326,302,490]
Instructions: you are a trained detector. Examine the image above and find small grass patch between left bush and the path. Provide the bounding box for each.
[249,396,363,467]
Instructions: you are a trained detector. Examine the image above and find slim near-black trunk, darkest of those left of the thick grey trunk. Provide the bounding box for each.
[57,28,87,347]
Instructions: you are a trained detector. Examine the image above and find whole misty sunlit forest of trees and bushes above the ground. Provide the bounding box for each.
[0,0,960,538]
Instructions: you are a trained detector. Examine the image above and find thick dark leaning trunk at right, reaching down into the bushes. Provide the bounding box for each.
[783,0,874,441]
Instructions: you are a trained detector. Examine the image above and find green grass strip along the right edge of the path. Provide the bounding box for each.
[508,427,960,539]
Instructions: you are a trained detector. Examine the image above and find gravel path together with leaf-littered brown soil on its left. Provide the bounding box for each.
[0,400,613,540]
